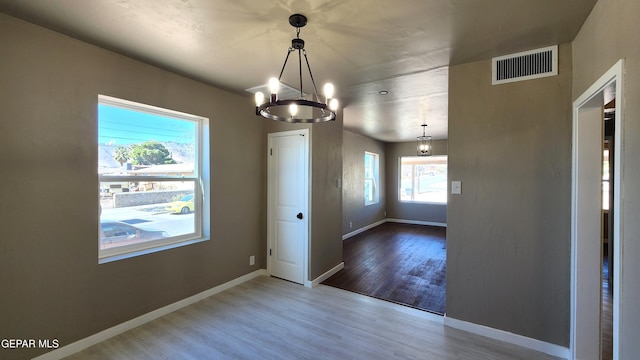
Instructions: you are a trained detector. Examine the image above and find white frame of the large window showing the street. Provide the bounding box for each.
[97,95,211,264]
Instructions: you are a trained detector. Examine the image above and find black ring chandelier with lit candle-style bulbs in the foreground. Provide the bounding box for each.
[255,14,338,123]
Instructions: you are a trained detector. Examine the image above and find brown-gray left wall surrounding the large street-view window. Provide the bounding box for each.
[0,14,268,359]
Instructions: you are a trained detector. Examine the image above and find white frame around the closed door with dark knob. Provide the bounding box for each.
[267,129,311,287]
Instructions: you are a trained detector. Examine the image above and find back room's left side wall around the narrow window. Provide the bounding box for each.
[342,131,387,235]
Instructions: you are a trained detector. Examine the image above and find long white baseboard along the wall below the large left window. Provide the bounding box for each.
[33,269,267,360]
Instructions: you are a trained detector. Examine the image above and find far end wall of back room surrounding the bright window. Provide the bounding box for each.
[386,140,447,224]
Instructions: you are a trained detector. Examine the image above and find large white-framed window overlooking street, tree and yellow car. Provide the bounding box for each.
[98,95,209,263]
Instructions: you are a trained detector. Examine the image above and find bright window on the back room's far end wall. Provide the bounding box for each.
[398,156,447,204]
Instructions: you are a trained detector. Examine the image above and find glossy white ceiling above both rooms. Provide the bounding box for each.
[0,0,596,142]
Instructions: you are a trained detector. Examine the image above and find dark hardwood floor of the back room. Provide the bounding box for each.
[323,223,446,314]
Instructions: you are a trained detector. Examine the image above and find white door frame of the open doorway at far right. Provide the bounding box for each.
[569,59,624,359]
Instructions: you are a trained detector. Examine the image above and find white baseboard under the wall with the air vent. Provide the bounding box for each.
[444,316,570,359]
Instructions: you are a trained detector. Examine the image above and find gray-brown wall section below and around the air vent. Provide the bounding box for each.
[447,44,572,346]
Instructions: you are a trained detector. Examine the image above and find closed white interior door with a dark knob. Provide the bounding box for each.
[267,129,309,284]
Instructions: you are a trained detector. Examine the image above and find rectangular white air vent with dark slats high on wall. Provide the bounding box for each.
[491,45,558,85]
